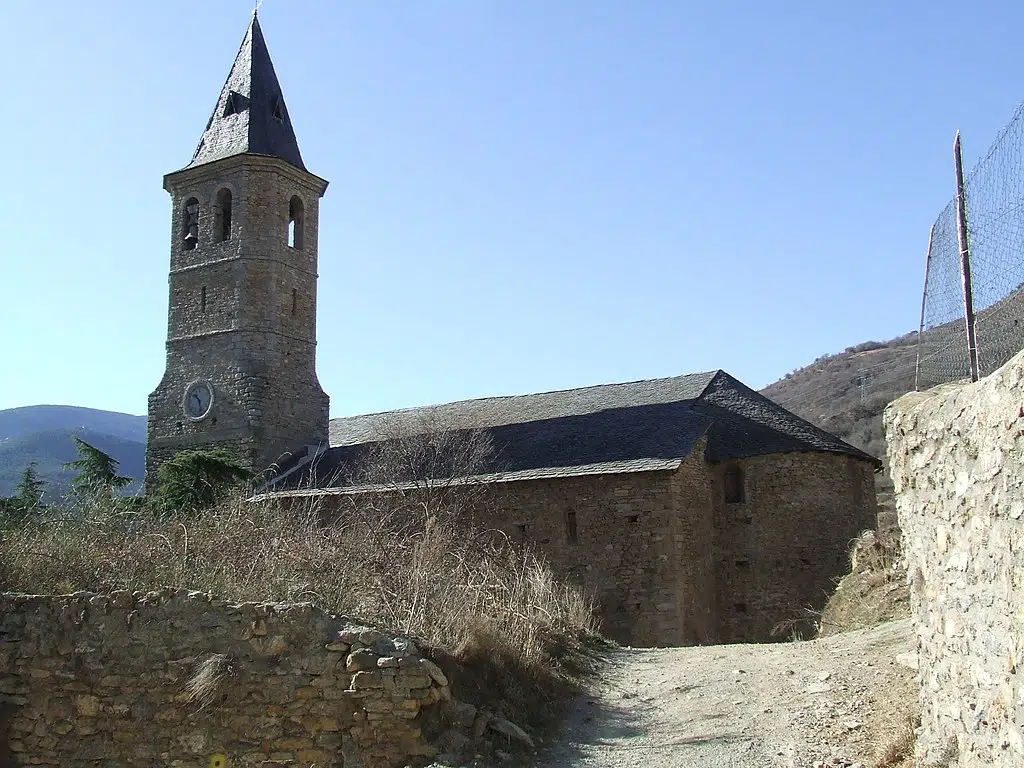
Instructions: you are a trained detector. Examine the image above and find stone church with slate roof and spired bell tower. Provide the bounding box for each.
[146,14,880,645]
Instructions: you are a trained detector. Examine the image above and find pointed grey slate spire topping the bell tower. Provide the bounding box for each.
[188,13,305,170]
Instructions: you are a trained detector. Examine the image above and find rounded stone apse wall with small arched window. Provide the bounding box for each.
[714,453,878,642]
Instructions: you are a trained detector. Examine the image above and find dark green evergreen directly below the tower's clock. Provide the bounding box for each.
[154,449,252,514]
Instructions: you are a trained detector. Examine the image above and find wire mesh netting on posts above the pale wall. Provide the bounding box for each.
[916,104,1024,389]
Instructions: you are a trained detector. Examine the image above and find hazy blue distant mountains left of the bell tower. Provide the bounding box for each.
[0,406,145,498]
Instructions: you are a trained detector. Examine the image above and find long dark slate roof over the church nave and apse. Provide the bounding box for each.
[270,371,879,490]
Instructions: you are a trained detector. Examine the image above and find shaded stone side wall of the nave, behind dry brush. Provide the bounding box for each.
[483,442,715,646]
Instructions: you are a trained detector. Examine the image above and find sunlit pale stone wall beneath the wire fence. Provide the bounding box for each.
[885,354,1024,768]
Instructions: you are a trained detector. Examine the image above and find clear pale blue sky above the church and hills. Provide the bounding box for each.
[0,0,1024,416]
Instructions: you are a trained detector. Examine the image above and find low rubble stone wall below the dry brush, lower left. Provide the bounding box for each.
[0,590,451,768]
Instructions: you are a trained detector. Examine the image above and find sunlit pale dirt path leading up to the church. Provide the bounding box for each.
[539,620,916,768]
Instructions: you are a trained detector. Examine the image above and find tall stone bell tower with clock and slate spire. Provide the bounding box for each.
[145,14,328,488]
